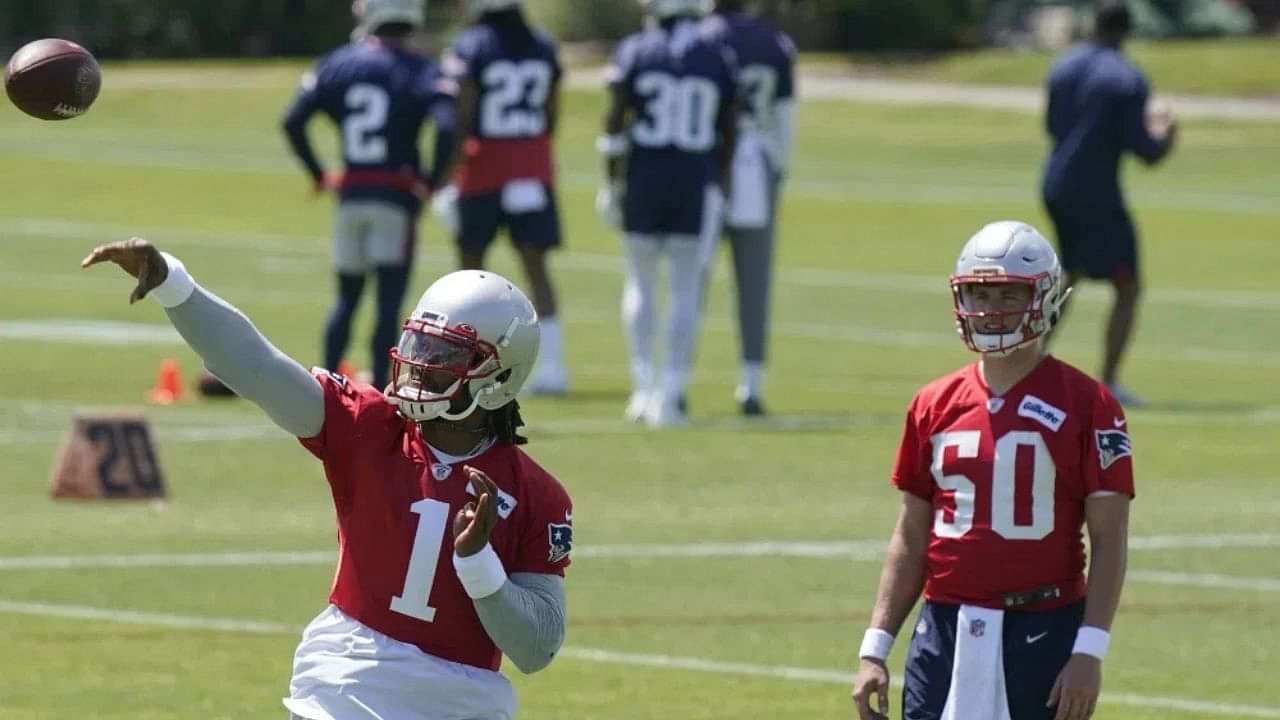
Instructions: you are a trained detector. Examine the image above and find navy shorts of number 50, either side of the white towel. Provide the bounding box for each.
[902,601,1084,720]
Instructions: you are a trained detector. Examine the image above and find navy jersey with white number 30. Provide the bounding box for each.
[608,19,737,196]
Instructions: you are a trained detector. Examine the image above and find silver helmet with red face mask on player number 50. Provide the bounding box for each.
[951,220,1071,355]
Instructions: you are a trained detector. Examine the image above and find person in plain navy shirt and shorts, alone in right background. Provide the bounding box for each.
[1042,1,1178,406]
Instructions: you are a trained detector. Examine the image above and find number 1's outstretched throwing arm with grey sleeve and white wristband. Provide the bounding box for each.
[81,238,324,437]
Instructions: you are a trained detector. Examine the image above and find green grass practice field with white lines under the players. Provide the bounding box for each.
[0,65,1280,720]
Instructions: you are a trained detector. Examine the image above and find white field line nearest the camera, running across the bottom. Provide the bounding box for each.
[0,600,1280,717]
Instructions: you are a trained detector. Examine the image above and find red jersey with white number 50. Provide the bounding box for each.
[892,356,1134,609]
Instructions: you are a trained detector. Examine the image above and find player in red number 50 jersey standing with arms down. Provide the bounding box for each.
[852,222,1133,720]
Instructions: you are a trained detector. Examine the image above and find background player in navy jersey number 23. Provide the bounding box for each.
[434,0,568,395]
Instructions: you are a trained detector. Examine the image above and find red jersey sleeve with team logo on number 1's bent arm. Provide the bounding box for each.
[507,459,573,577]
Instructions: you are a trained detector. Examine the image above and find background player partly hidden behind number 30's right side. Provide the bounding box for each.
[716,0,796,415]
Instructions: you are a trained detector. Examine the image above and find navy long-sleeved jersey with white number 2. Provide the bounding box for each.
[284,38,454,209]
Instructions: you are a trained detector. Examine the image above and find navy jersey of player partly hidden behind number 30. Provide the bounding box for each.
[709,13,796,129]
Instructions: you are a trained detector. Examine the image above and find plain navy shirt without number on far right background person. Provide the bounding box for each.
[1042,44,1169,208]
